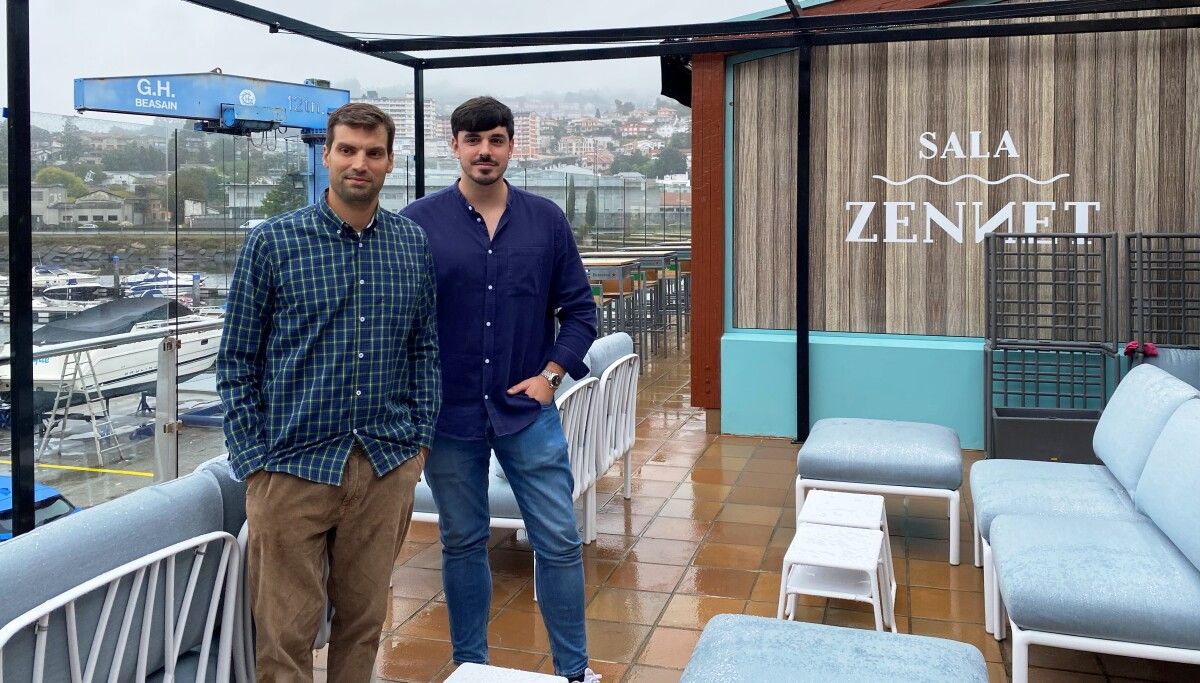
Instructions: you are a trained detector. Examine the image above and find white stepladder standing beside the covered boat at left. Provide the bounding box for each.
[35,351,125,467]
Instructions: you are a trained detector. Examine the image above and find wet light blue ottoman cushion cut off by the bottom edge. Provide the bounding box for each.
[680,615,988,683]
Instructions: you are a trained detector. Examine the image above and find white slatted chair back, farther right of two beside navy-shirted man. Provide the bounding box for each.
[593,353,642,504]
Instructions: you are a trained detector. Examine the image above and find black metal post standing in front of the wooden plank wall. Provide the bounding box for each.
[796,42,812,442]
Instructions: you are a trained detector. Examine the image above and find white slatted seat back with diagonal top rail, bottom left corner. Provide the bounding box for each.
[0,532,241,683]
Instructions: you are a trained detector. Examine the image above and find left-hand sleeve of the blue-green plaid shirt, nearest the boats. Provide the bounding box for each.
[217,228,274,479]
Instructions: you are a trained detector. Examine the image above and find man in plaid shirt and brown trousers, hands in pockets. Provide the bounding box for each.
[217,103,442,682]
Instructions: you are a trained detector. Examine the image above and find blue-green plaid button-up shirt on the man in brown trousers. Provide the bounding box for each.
[217,193,442,486]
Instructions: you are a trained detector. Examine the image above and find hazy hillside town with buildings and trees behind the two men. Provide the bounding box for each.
[11,90,691,228]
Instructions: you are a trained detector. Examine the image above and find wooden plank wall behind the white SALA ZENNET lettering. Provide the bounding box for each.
[733,17,1200,336]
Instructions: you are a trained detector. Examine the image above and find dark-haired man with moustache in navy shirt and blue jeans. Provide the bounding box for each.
[402,97,599,681]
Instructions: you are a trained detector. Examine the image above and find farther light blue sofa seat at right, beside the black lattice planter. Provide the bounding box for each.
[971,365,1200,633]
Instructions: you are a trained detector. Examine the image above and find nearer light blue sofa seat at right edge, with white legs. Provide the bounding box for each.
[990,396,1200,683]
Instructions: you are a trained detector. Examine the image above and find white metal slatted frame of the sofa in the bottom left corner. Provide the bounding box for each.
[0,532,241,683]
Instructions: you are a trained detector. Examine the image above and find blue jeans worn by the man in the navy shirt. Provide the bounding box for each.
[425,405,588,677]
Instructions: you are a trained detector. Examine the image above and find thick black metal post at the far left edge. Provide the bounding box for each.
[6,0,36,535]
